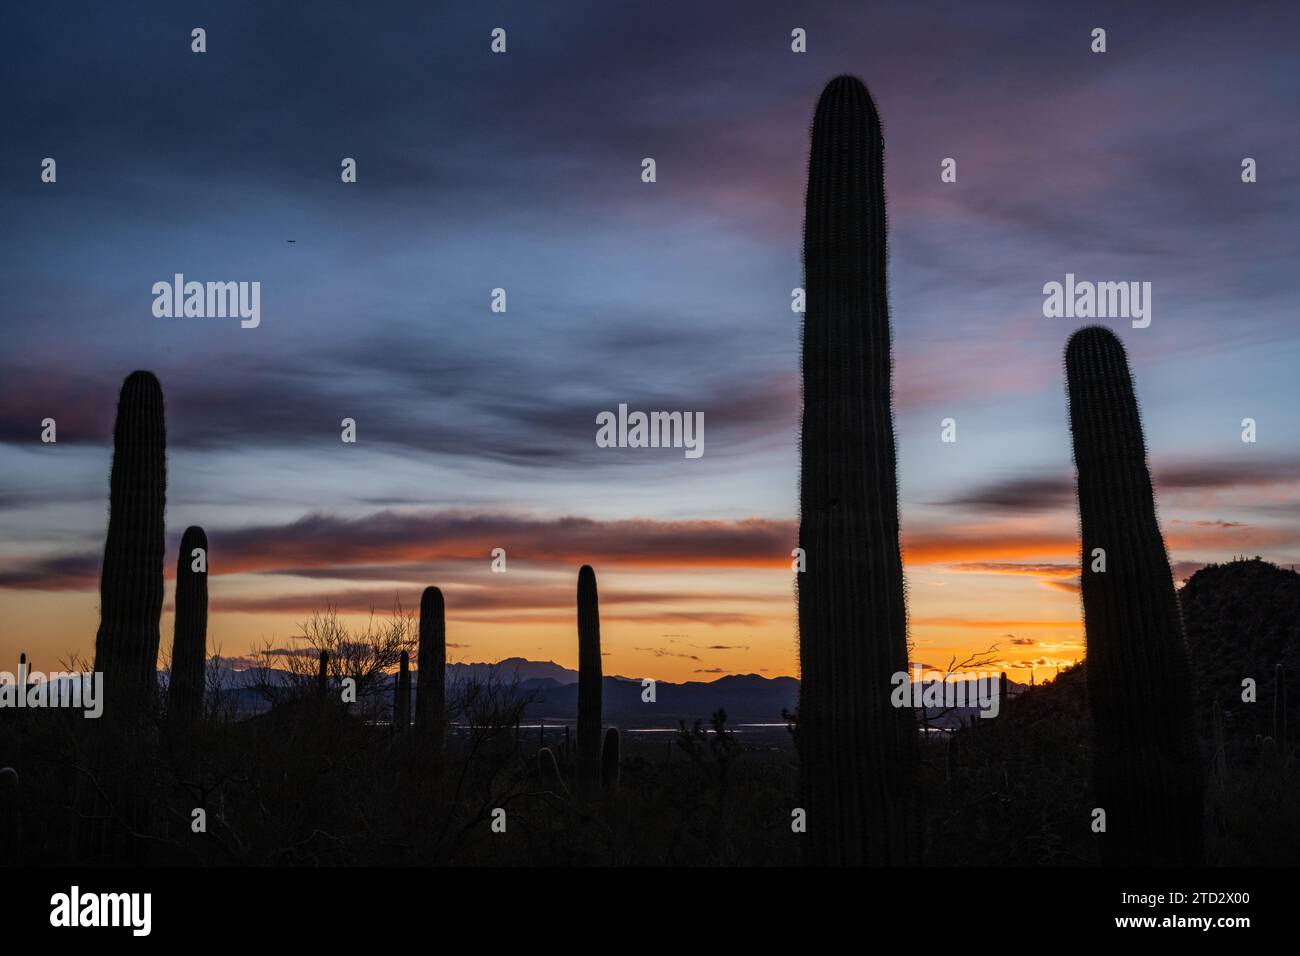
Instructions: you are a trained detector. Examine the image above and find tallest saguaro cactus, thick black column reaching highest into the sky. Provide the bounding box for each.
[797,77,920,865]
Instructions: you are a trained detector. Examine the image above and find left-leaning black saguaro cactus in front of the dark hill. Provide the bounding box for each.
[1065,326,1204,865]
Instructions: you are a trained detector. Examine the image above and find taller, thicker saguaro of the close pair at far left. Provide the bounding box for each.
[95,372,166,719]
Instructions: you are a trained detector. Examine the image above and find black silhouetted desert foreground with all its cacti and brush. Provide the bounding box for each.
[0,83,1300,866]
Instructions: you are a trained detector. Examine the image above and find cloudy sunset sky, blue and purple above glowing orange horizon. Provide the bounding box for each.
[0,0,1300,680]
